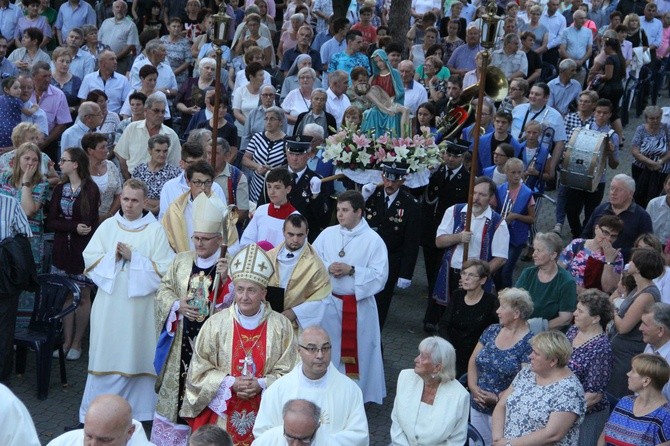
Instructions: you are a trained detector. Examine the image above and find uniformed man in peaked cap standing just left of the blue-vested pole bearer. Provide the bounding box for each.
[421,140,470,333]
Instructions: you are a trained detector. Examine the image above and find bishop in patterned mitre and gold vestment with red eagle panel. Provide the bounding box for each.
[180,244,297,444]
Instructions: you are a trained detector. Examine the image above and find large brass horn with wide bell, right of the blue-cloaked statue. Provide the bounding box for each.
[440,66,508,138]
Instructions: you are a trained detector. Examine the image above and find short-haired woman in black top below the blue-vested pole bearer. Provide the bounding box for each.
[438,259,498,376]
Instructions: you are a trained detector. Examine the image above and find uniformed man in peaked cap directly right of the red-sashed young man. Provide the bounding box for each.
[365,163,421,330]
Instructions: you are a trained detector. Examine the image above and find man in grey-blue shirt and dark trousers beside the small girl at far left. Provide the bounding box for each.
[30,62,72,160]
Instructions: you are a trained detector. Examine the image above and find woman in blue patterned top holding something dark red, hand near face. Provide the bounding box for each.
[558,215,624,293]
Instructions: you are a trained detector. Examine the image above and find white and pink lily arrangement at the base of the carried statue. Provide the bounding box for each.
[323,127,442,173]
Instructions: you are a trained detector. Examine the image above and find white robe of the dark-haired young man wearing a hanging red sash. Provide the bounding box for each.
[312,220,388,404]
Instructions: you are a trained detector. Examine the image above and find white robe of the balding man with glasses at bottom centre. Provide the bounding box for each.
[254,363,370,446]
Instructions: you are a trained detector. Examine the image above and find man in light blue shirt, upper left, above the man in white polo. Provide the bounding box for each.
[77,50,133,114]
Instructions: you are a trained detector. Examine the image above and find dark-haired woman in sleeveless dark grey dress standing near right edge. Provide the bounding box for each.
[607,248,665,398]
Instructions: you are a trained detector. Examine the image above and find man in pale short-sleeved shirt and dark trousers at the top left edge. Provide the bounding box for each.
[98,0,140,73]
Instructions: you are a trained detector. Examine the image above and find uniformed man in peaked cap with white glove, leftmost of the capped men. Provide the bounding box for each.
[270,135,330,243]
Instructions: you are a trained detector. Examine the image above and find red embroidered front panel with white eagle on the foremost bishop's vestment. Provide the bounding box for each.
[226,320,268,446]
